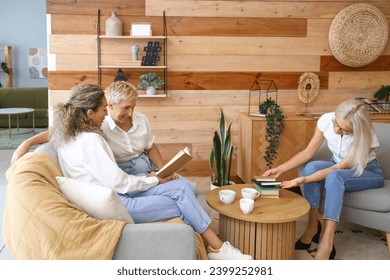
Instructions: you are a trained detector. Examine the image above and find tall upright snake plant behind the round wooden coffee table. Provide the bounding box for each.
[209,109,234,188]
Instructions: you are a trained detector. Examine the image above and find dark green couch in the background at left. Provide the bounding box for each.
[0,88,49,127]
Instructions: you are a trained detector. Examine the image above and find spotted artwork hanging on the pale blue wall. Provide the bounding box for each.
[28,48,47,79]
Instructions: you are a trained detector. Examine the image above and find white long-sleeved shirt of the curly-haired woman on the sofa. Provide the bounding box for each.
[58,132,158,193]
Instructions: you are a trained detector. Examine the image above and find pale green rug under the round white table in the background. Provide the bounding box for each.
[0,128,47,150]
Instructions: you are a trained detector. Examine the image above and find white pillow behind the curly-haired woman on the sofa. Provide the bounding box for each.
[56,176,134,224]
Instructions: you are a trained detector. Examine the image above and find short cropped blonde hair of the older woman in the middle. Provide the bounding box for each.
[106,81,138,105]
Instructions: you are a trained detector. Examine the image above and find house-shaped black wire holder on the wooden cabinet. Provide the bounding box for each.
[248,78,278,117]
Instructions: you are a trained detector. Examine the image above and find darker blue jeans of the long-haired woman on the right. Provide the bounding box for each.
[303,159,384,222]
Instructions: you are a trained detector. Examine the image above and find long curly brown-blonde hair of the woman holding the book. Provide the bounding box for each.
[50,84,104,148]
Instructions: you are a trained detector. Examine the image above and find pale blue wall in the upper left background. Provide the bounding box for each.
[0,0,47,87]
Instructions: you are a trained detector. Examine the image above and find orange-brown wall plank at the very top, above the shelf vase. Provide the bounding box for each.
[46,0,145,15]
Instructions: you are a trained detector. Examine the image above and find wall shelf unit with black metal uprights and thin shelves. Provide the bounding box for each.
[97,11,168,97]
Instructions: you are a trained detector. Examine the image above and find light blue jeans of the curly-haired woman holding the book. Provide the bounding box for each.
[119,179,211,233]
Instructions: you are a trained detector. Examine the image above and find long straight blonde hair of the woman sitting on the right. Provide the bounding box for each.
[335,99,374,176]
